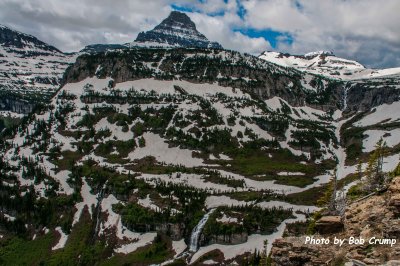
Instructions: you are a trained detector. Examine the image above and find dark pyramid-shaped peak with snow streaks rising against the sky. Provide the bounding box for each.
[135,11,222,49]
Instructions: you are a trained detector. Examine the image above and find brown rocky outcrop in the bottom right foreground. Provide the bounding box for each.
[271,177,400,265]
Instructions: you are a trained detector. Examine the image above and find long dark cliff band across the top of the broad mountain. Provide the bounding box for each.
[65,48,400,111]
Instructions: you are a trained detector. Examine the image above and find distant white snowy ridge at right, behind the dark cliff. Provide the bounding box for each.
[259,51,400,80]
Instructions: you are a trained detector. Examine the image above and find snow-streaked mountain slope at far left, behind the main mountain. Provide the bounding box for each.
[0,26,75,113]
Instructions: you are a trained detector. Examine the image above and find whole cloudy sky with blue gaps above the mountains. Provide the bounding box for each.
[0,0,400,68]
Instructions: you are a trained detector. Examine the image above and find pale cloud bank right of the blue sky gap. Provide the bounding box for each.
[244,0,400,67]
